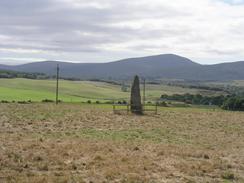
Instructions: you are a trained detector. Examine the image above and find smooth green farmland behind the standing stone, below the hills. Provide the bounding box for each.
[0,79,223,102]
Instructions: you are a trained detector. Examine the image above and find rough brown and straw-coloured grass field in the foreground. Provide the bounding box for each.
[0,104,244,183]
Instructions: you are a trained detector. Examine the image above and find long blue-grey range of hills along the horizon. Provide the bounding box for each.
[0,54,244,80]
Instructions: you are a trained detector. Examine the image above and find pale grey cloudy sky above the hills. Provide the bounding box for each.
[0,0,244,64]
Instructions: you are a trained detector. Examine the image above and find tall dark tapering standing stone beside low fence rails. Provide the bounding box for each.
[130,76,142,114]
